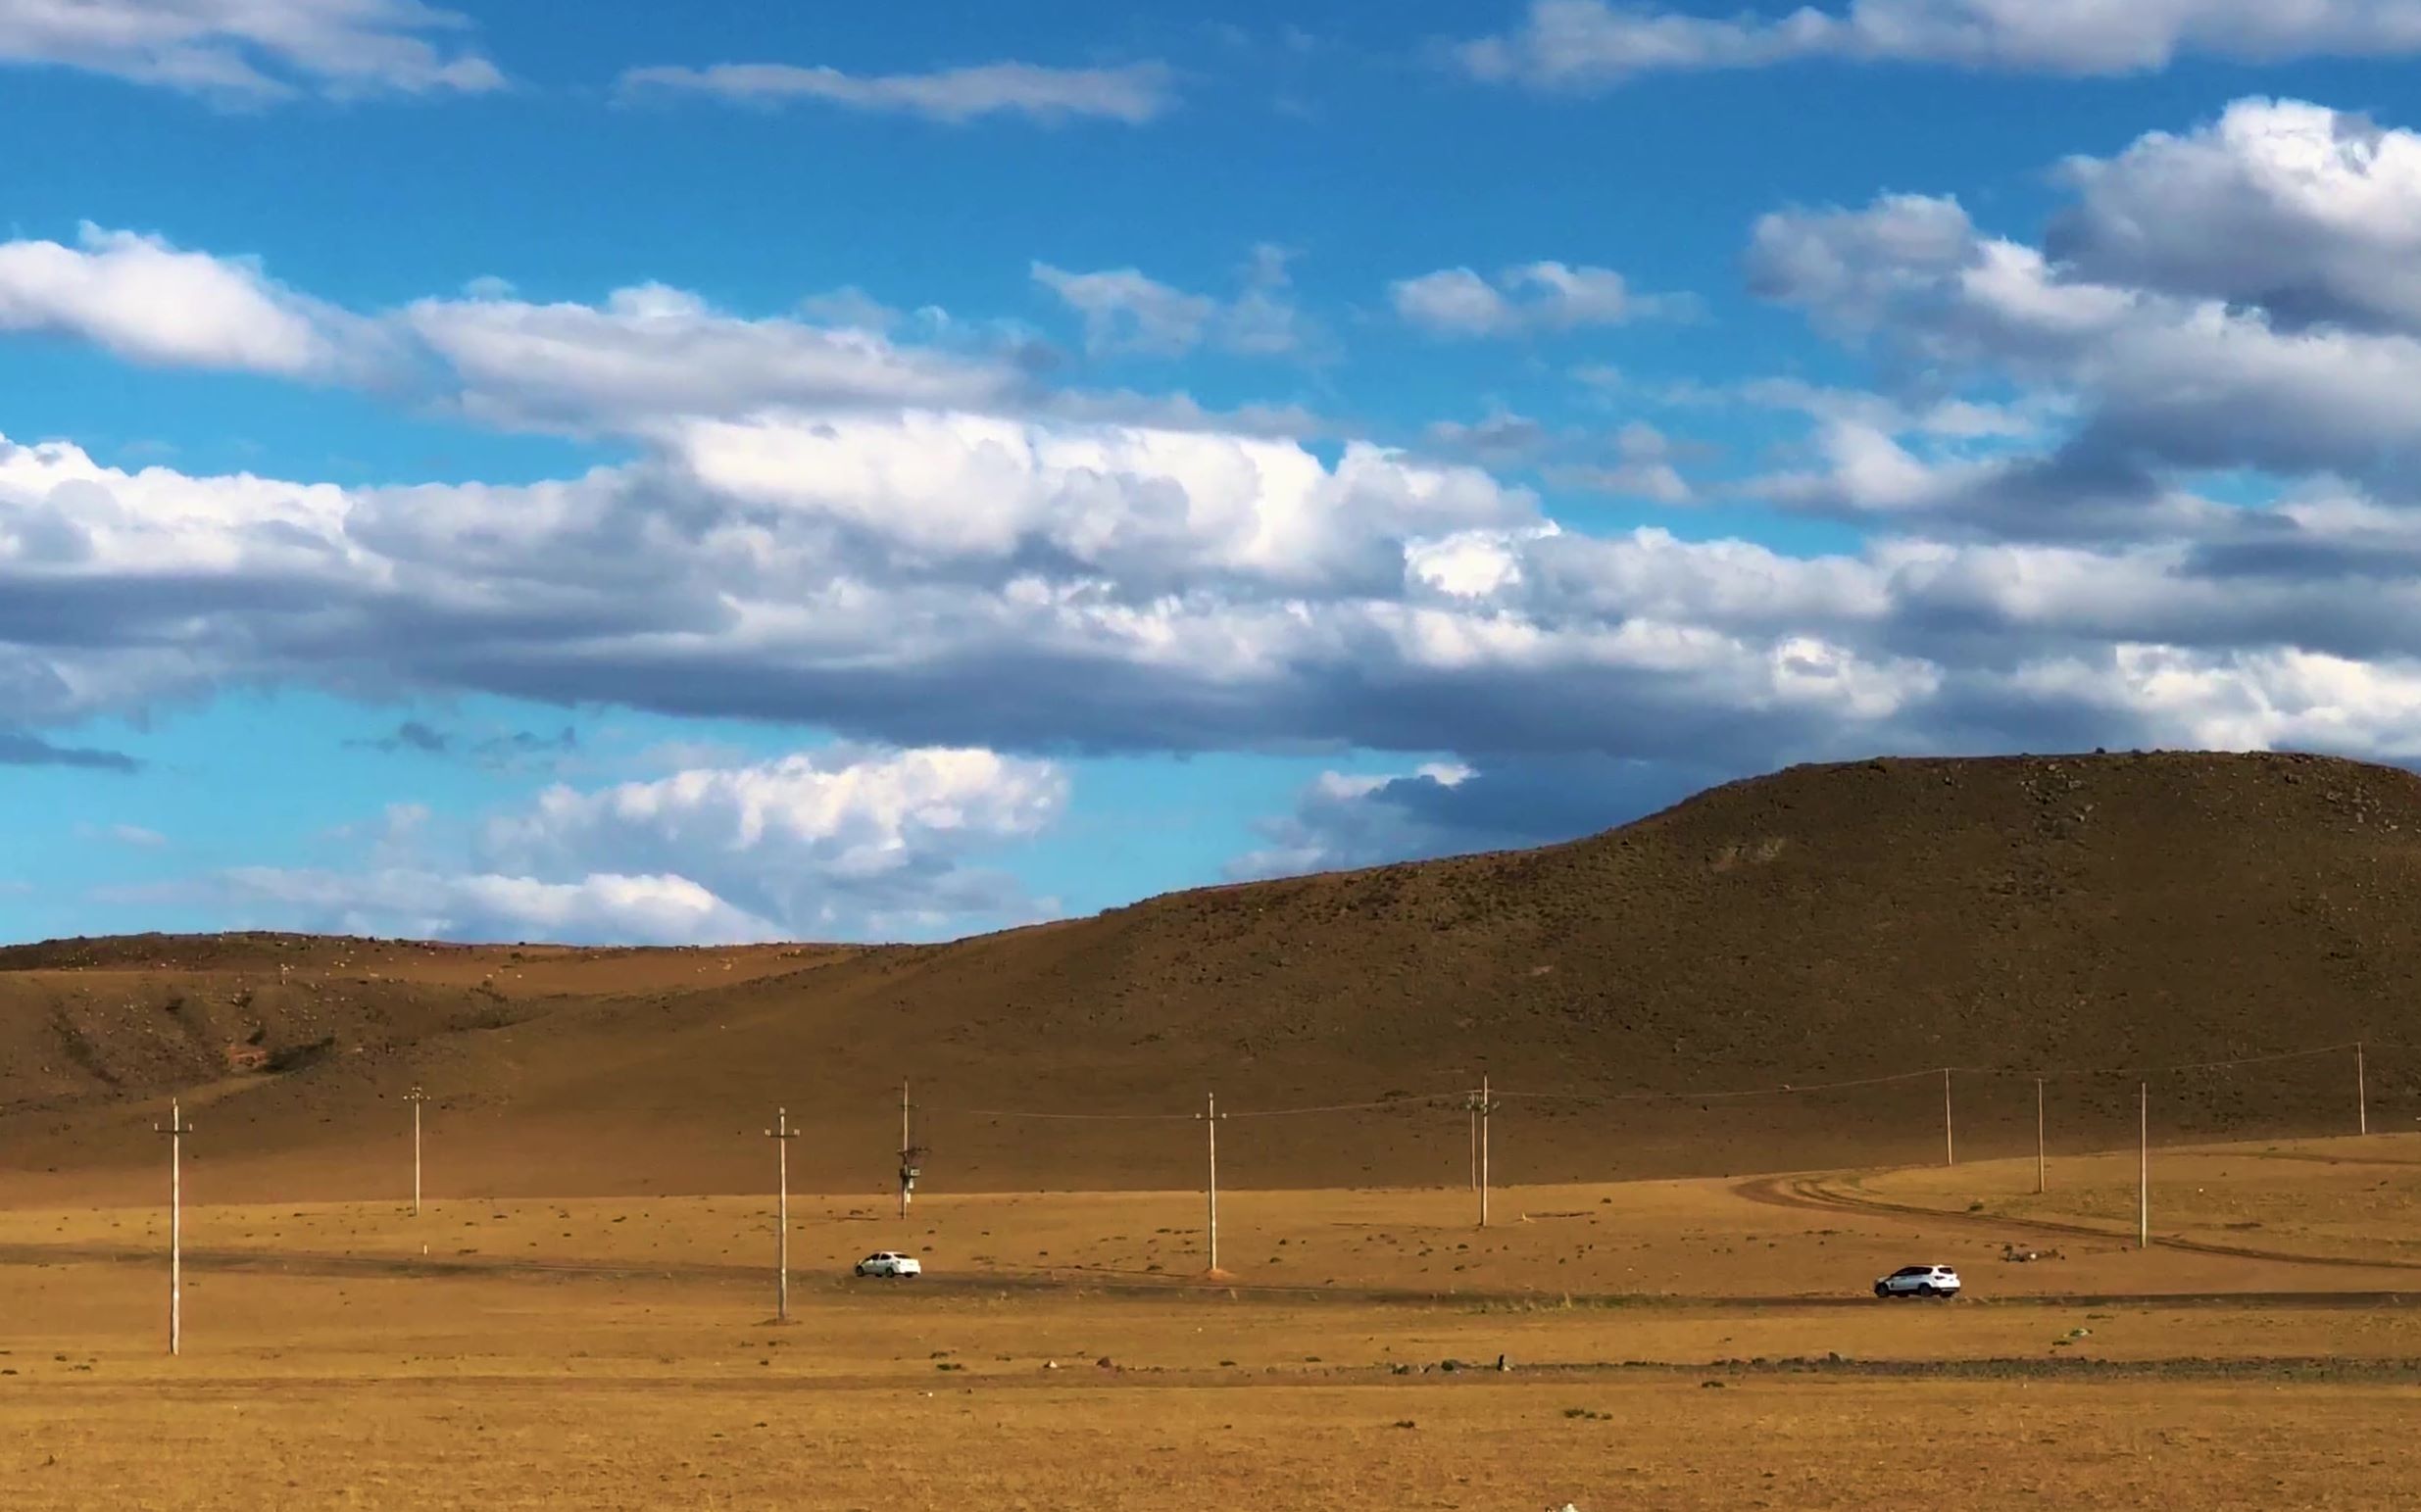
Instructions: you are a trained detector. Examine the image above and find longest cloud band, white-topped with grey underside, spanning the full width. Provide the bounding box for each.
[24,360,2421,778]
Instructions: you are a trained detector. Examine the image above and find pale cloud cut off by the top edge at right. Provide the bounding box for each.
[1455,0,2421,89]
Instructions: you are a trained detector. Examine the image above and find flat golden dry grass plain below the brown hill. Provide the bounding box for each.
[14,1135,2421,1512]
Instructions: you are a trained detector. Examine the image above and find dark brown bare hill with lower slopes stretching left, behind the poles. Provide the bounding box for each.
[0,755,2421,1200]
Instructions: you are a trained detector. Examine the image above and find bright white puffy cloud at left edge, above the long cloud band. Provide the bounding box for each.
[0,225,368,377]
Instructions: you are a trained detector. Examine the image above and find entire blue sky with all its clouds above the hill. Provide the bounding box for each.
[0,0,2421,944]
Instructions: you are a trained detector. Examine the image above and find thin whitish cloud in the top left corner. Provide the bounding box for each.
[0,0,504,102]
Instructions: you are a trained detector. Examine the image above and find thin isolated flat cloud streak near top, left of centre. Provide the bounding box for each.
[622,63,1176,125]
